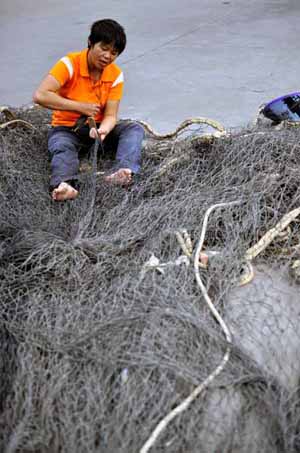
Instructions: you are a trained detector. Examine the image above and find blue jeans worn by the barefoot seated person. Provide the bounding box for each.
[48,121,145,189]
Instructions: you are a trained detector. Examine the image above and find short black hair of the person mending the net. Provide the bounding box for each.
[88,19,126,55]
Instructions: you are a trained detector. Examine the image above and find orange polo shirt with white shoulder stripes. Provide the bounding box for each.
[49,49,124,126]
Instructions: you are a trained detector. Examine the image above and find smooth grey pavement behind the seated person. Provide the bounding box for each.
[0,0,300,132]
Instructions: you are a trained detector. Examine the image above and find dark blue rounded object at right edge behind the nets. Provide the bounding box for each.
[262,92,300,122]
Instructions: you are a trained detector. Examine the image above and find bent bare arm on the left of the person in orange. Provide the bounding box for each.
[33,74,100,116]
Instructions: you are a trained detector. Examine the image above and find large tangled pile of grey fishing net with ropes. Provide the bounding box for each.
[0,108,300,453]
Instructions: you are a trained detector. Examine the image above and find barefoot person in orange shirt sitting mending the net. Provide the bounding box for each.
[33,19,144,201]
